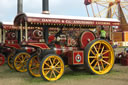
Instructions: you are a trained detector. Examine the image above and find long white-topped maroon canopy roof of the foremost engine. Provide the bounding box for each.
[14,13,120,26]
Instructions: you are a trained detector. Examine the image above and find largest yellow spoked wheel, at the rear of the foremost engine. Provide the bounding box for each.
[85,39,115,74]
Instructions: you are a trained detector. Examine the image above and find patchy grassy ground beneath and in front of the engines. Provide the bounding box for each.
[0,64,128,85]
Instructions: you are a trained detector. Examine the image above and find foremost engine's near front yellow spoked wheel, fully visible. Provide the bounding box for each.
[40,54,64,81]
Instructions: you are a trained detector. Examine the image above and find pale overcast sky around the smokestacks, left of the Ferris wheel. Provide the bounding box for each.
[0,0,87,22]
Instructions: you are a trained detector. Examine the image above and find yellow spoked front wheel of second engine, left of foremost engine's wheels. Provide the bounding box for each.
[14,52,30,72]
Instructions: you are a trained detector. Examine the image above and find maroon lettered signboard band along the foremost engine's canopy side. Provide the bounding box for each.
[28,17,119,26]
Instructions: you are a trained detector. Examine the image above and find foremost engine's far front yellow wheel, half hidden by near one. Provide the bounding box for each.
[27,56,41,77]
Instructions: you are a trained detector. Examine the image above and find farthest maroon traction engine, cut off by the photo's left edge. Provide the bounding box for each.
[0,22,20,68]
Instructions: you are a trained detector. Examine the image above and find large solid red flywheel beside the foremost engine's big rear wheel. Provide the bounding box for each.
[80,30,96,48]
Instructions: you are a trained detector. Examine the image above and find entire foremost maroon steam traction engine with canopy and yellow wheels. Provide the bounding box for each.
[14,13,120,81]
